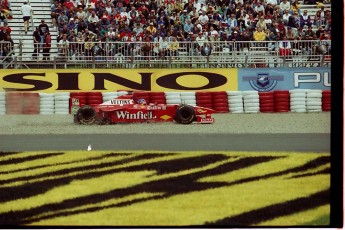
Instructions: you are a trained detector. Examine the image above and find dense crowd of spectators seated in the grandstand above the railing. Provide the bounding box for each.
[0,0,331,61]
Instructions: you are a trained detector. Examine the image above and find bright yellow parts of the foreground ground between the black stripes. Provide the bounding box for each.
[0,151,330,226]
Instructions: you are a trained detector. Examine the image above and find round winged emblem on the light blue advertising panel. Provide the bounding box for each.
[243,73,284,92]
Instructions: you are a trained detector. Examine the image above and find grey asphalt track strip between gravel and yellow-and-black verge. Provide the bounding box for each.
[0,133,330,152]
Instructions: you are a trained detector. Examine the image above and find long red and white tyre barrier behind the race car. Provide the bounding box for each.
[0,89,331,115]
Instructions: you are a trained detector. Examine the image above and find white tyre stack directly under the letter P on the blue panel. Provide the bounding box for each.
[289,89,307,113]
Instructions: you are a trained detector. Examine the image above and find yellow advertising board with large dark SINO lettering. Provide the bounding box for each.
[0,69,238,93]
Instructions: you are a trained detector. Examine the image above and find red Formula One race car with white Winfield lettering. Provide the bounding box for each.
[72,95,215,125]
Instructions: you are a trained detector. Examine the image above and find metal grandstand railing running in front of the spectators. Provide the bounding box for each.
[2,40,331,69]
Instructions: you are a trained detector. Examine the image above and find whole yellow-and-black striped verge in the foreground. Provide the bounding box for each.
[0,151,330,226]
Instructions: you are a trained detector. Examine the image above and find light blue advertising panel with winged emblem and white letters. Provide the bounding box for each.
[238,67,331,92]
